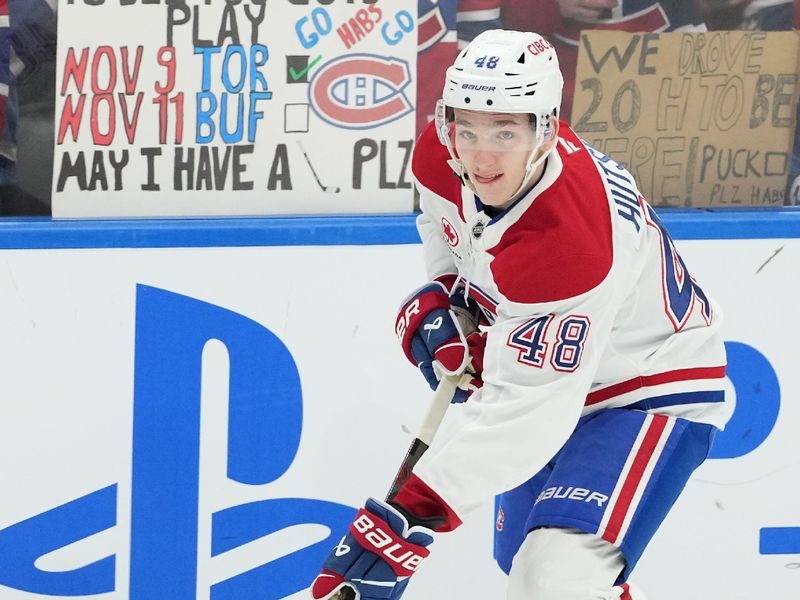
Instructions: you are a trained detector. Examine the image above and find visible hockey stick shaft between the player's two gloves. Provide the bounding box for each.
[331,373,462,600]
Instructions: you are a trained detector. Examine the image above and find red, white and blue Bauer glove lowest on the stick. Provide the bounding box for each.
[311,498,433,600]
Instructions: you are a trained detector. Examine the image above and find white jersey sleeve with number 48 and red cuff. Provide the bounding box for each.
[400,278,615,531]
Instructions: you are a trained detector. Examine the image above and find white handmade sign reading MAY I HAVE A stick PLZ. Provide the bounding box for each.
[53,0,417,217]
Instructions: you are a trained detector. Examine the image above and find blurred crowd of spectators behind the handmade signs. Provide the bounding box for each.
[0,0,800,216]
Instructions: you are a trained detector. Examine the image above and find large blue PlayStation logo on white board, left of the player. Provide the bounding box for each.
[0,285,356,600]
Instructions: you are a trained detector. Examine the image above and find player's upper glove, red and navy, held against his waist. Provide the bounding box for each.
[395,281,476,389]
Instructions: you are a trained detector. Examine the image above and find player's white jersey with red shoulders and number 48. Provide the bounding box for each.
[403,122,732,530]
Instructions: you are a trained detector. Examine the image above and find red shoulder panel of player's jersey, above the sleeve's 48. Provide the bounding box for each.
[491,122,614,304]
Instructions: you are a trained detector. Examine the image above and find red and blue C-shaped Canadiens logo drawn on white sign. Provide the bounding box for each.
[308,54,414,129]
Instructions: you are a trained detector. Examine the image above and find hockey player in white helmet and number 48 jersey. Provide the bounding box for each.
[312,30,731,600]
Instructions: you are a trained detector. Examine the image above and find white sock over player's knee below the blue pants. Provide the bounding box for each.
[507,527,636,600]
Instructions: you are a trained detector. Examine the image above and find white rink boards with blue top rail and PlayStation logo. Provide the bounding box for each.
[0,211,800,600]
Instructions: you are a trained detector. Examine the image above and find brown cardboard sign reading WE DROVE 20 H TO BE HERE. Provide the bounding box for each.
[572,31,798,207]
